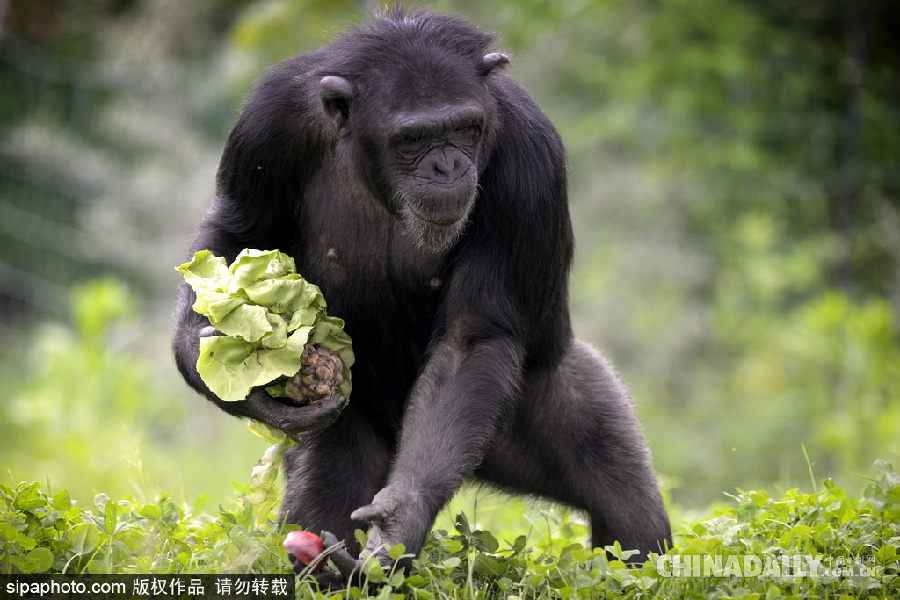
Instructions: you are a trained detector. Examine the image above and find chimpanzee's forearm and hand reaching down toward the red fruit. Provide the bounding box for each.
[352,318,523,563]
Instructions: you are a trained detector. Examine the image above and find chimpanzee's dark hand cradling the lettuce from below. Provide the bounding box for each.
[198,325,347,439]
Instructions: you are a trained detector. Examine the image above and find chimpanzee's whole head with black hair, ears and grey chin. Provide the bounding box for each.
[320,13,509,251]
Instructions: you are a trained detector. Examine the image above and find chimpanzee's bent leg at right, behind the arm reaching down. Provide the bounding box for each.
[476,340,671,560]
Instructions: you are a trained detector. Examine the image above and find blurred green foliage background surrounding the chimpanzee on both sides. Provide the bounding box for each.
[0,0,900,516]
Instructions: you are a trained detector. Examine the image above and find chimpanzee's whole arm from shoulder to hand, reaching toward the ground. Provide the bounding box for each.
[353,79,572,562]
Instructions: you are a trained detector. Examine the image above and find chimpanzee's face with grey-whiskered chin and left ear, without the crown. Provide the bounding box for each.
[322,57,496,251]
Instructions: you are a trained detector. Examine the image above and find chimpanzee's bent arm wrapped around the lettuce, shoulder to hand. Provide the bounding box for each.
[172,56,345,435]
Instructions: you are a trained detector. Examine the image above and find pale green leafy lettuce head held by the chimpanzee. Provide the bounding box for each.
[176,249,354,402]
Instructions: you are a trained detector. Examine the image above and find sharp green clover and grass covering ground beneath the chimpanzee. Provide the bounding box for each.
[0,455,900,599]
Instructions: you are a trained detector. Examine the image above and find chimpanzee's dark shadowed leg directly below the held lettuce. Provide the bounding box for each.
[280,403,390,554]
